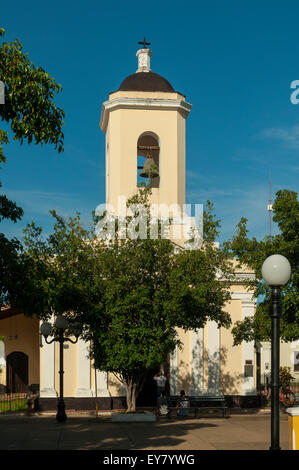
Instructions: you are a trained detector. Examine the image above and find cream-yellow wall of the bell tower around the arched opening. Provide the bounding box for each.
[106,105,185,209]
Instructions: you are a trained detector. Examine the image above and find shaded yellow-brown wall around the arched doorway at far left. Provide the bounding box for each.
[0,315,39,385]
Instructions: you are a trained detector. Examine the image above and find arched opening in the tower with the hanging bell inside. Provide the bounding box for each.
[137,132,160,188]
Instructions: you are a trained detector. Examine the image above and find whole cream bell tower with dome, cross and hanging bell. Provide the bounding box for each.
[100,39,192,210]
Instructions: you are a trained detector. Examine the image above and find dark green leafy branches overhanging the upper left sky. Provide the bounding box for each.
[0,29,64,156]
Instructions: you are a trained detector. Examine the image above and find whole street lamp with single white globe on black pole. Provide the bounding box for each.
[262,255,291,450]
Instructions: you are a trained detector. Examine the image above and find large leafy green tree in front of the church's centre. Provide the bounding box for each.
[16,188,230,411]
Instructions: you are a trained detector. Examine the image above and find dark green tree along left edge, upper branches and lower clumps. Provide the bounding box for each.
[0,28,64,304]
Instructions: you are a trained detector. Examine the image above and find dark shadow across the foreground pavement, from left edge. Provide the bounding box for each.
[0,416,218,450]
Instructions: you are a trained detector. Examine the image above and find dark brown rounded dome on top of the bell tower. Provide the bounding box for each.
[119,72,175,93]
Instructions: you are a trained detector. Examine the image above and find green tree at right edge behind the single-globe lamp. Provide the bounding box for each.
[226,189,299,344]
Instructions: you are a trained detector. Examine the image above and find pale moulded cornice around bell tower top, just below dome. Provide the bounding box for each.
[100,97,192,132]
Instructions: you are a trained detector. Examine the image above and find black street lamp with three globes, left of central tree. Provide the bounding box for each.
[40,315,82,422]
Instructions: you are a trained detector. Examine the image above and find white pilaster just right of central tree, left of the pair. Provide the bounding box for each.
[189,328,204,395]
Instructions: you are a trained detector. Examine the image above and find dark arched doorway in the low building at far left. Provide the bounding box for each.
[6,352,28,393]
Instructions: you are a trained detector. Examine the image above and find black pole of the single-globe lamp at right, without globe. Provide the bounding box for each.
[270,286,281,450]
